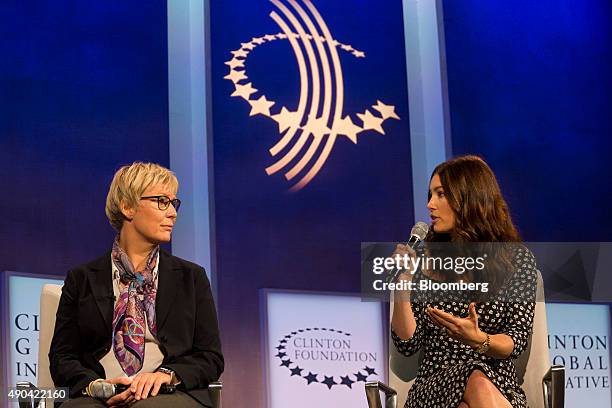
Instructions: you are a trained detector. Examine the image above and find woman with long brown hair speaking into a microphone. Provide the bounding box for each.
[391,156,537,408]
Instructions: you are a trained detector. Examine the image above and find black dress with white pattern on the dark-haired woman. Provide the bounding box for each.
[391,246,537,408]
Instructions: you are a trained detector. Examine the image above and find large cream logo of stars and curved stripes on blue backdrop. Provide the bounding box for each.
[224,0,399,191]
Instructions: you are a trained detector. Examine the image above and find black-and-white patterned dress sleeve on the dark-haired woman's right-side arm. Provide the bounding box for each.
[503,248,537,359]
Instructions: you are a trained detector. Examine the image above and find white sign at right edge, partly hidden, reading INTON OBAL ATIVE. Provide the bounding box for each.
[546,303,612,408]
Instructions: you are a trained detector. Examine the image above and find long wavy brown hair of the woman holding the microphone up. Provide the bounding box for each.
[426,155,521,295]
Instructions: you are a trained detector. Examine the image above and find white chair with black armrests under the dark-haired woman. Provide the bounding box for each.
[365,272,565,408]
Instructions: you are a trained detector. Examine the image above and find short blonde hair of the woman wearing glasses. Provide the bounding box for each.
[105,162,178,232]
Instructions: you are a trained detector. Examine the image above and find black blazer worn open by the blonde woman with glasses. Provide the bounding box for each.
[49,250,223,406]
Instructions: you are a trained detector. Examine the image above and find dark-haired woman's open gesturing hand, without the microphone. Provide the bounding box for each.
[426,303,487,347]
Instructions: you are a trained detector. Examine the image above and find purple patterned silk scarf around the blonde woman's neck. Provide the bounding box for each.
[112,236,159,376]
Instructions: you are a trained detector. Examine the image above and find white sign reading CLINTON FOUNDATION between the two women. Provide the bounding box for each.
[263,291,388,408]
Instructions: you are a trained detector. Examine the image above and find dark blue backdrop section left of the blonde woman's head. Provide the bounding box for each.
[0,1,169,275]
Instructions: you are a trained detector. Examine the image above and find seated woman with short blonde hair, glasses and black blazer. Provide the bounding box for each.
[49,162,224,408]
